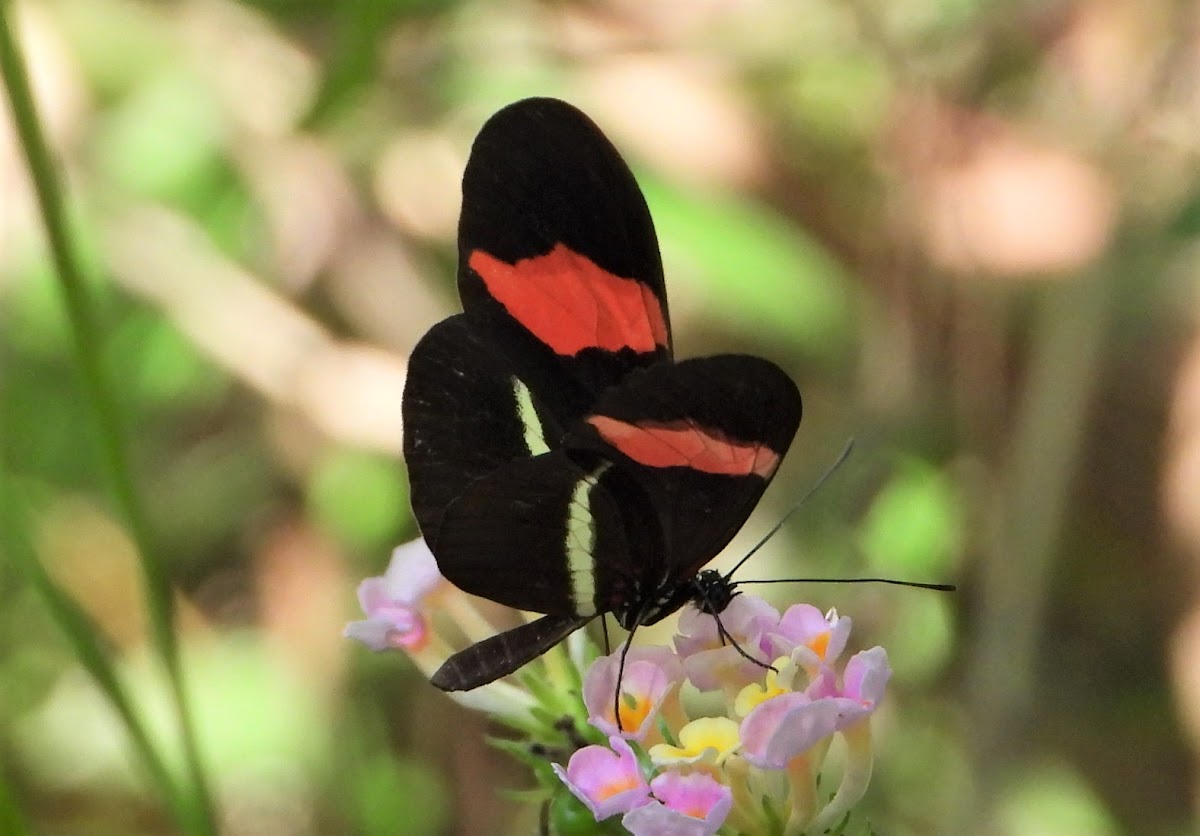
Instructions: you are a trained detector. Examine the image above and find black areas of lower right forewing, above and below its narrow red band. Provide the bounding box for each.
[564,355,802,583]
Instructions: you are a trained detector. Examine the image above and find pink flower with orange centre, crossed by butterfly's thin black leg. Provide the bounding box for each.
[583,646,683,740]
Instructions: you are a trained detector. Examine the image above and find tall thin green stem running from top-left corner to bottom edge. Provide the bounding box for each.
[0,8,216,834]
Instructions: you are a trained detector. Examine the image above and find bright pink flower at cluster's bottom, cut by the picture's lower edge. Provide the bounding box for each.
[620,771,733,836]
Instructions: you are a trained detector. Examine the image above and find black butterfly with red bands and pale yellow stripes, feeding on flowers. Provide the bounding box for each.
[403,98,800,691]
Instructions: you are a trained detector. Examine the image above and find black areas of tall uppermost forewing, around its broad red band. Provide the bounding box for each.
[458,98,671,426]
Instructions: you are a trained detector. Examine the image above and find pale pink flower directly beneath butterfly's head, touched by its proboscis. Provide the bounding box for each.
[674,595,779,691]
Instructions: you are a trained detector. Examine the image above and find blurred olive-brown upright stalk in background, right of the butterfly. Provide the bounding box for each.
[954,261,1118,832]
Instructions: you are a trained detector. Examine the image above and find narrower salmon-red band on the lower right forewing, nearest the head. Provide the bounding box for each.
[588,415,779,479]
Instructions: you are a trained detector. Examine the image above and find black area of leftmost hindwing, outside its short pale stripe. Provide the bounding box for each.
[403,314,560,546]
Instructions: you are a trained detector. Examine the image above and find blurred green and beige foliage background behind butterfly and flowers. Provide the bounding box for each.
[0,0,1200,836]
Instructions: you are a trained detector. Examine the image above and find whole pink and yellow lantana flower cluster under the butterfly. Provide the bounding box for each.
[346,543,892,836]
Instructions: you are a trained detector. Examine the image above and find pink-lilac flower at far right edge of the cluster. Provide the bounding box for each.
[742,648,892,769]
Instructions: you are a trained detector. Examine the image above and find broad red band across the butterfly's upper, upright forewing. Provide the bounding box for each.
[468,243,667,356]
